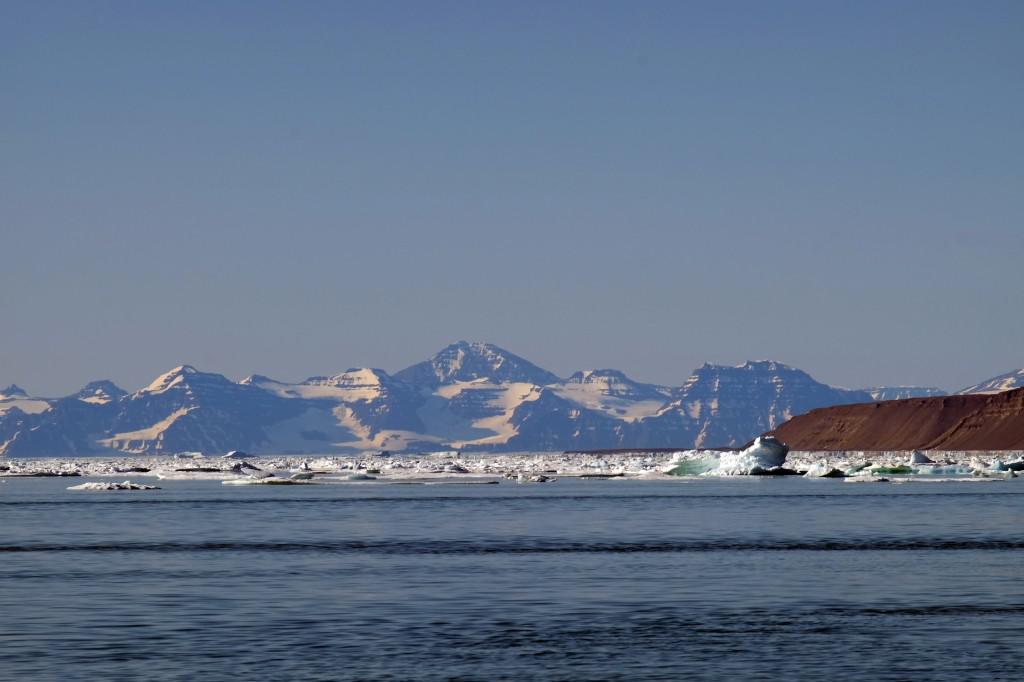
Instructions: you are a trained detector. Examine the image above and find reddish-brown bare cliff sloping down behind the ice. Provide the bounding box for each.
[770,388,1024,451]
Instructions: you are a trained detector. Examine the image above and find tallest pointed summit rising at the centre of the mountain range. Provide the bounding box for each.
[394,341,559,388]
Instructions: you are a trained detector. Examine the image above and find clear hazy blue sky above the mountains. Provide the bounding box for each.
[0,0,1024,395]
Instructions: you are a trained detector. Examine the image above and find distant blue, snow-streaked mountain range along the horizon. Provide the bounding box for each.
[0,341,1024,457]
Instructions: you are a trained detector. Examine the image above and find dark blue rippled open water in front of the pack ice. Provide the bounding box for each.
[0,479,1024,681]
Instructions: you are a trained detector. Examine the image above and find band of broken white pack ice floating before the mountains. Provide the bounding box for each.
[0,439,1024,483]
